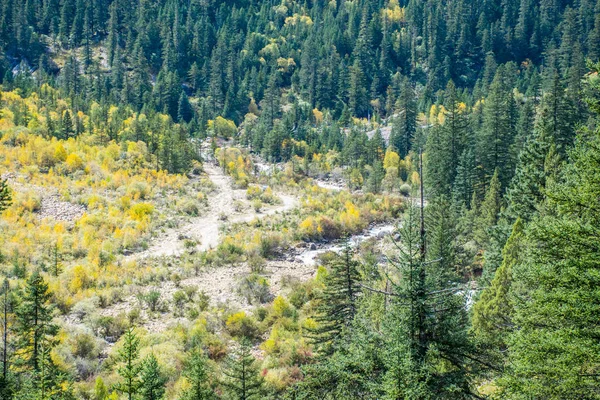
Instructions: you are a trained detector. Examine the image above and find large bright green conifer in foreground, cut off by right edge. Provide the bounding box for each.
[502,65,600,399]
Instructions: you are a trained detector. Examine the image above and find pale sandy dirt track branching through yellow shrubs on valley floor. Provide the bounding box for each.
[132,163,299,259]
